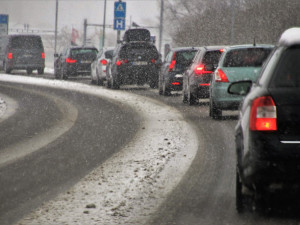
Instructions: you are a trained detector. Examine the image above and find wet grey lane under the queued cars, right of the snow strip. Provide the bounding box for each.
[126,88,299,225]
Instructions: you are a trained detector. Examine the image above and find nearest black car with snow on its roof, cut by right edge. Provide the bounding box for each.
[228,28,300,212]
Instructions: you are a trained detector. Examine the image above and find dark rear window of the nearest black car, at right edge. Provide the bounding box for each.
[272,46,300,88]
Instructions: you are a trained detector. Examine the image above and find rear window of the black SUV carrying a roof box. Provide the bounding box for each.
[120,44,159,59]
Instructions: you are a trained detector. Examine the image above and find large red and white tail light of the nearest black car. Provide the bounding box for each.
[250,96,277,131]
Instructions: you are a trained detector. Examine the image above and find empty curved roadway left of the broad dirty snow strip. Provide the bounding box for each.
[0,83,139,224]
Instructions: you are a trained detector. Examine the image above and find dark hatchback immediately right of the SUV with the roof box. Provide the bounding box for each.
[158,47,199,96]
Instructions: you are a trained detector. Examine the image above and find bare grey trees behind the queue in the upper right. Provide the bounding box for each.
[165,0,300,46]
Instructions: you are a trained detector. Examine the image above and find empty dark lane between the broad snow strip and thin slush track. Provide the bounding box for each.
[0,85,140,224]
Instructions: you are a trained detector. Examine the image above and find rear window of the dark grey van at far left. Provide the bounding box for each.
[11,36,43,49]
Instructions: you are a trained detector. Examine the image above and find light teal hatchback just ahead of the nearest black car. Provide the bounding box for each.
[209,43,274,119]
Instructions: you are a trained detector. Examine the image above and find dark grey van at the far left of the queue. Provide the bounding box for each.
[0,34,45,74]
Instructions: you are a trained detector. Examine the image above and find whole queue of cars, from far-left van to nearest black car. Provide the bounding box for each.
[0,28,300,213]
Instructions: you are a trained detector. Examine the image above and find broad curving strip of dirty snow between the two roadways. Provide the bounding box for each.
[0,75,198,225]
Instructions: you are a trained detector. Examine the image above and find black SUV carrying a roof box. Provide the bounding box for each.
[106,29,159,89]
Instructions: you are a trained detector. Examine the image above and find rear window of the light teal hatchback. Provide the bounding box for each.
[223,48,272,67]
